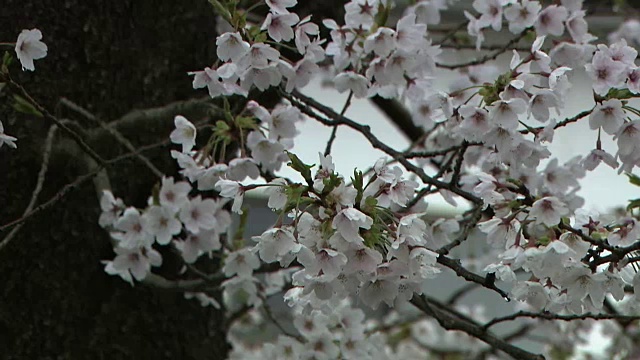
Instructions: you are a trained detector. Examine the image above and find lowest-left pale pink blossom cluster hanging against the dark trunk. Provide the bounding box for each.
[100,178,231,285]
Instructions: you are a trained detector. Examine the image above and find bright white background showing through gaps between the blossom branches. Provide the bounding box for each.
[281,50,640,212]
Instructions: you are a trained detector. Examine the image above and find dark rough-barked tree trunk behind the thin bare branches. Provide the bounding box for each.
[0,0,228,359]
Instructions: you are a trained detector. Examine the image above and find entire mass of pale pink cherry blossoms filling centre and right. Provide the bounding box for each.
[94,0,640,358]
